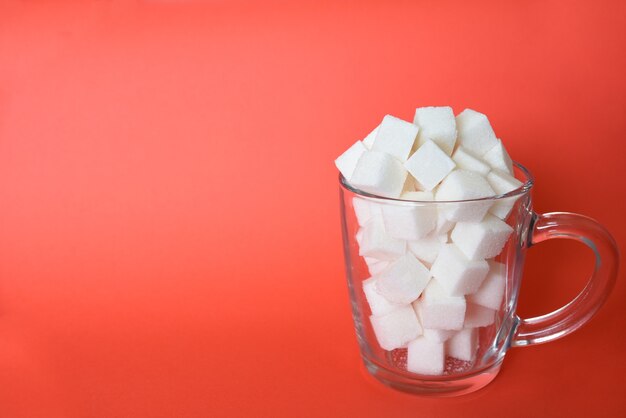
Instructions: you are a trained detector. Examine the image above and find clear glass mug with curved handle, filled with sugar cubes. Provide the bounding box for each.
[339,163,619,396]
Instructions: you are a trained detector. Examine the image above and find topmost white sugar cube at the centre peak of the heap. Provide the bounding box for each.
[413,106,456,155]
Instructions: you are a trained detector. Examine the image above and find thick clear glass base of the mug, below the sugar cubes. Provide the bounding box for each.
[363,357,502,397]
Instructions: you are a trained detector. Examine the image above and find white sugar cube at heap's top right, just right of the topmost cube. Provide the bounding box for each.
[456,109,498,157]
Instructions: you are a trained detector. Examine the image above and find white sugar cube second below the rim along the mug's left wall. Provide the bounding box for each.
[357,218,406,260]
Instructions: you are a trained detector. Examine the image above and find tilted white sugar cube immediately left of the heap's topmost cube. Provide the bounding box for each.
[372,115,419,162]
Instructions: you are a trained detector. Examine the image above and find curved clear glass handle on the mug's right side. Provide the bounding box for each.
[511,212,619,347]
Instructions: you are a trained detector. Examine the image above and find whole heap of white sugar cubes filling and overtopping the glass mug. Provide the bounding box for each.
[335,107,522,375]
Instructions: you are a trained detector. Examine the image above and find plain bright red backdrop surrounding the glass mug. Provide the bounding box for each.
[0,0,626,417]
